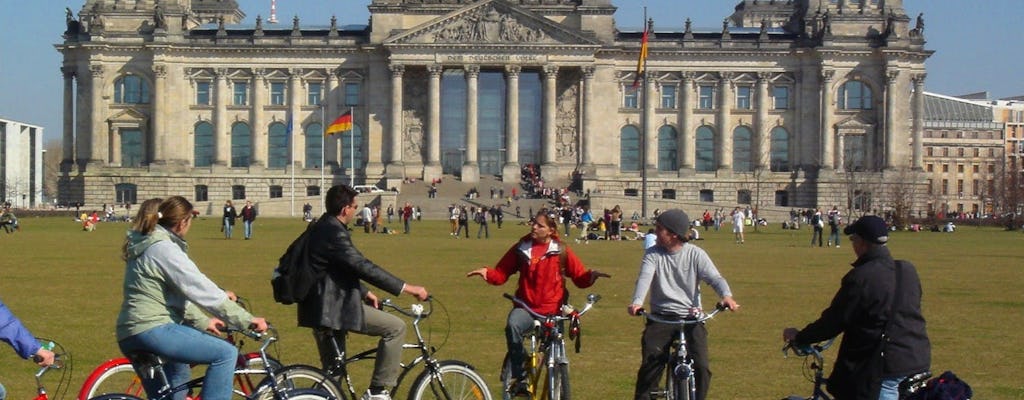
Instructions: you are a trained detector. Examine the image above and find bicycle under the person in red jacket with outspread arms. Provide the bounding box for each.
[504,294,601,400]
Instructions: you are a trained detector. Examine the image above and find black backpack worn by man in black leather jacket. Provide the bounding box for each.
[270,223,323,304]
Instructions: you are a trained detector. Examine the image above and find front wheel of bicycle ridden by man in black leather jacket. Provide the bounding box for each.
[409,360,492,400]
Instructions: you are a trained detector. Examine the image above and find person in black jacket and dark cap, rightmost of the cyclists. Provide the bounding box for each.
[782,216,931,400]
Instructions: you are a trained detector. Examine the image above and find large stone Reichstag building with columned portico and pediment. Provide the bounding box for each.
[56,0,932,215]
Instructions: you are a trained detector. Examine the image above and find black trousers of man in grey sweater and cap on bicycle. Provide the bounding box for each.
[633,321,711,400]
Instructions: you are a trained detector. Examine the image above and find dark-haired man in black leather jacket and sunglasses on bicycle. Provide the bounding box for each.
[298,185,428,400]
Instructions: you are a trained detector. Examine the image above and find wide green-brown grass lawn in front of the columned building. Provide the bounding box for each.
[0,218,1024,400]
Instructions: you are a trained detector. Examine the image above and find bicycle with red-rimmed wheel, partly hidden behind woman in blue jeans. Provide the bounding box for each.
[78,298,282,400]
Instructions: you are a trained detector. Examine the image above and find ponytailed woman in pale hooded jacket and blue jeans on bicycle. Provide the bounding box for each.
[117,196,266,400]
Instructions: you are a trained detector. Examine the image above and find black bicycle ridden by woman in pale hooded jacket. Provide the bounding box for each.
[90,331,336,400]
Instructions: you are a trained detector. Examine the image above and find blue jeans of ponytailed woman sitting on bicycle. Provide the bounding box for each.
[118,323,239,400]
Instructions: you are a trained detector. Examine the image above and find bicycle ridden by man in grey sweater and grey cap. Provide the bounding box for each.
[637,303,728,400]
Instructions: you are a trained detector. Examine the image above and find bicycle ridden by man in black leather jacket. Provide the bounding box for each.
[313,298,492,400]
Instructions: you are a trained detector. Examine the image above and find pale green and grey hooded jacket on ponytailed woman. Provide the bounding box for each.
[117,225,253,341]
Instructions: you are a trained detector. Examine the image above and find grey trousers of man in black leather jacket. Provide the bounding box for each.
[313,305,406,389]
